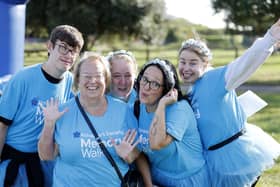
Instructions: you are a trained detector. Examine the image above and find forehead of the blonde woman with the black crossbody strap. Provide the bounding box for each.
[80,59,104,74]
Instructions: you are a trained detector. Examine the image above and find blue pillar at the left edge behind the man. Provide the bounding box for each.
[0,0,27,77]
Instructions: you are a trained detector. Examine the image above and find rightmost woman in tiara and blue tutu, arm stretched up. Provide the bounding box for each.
[178,19,280,187]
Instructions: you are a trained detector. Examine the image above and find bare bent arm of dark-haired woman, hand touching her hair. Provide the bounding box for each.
[149,89,178,150]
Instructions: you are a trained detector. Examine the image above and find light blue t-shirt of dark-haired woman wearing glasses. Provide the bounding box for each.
[138,100,205,179]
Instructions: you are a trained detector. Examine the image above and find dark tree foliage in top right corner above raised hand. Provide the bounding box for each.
[212,0,280,35]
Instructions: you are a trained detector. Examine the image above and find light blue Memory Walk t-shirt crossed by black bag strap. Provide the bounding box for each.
[53,96,136,187]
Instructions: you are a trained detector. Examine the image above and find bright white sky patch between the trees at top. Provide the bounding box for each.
[165,0,225,28]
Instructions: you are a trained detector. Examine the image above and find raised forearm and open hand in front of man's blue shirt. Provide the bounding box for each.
[38,98,67,160]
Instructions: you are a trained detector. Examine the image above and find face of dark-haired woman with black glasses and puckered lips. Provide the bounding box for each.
[139,66,164,112]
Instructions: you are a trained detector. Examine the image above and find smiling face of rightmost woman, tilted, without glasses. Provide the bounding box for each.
[178,49,207,85]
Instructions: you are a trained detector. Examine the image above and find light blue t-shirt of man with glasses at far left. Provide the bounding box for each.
[0,64,73,152]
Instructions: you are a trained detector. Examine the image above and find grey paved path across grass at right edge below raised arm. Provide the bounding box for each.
[237,84,280,94]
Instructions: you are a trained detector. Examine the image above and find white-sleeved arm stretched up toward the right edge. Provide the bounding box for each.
[225,19,280,91]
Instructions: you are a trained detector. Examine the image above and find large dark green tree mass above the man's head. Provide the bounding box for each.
[27,0,162,48]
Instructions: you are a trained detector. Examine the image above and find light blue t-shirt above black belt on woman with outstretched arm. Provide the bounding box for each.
[188,66,246,149]
